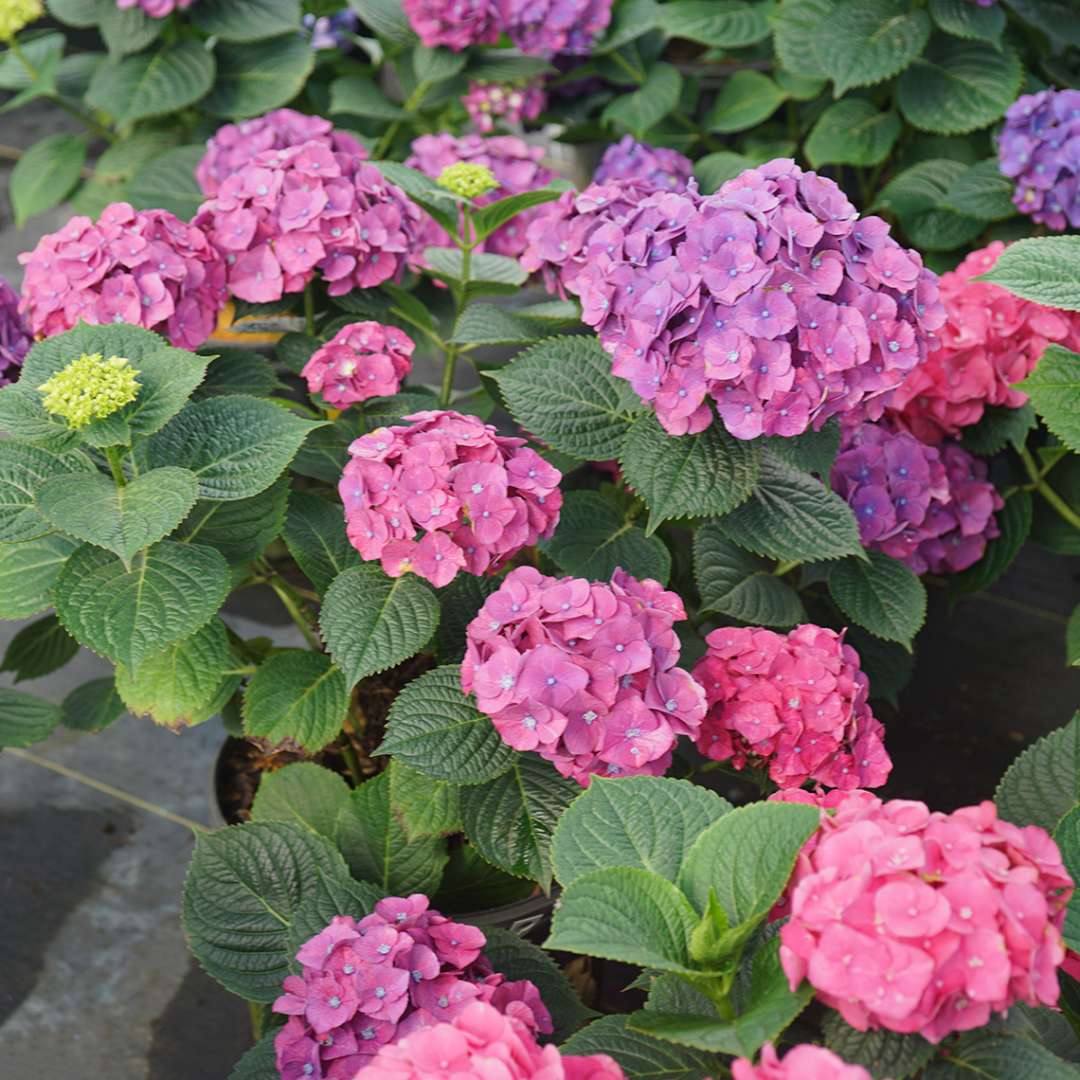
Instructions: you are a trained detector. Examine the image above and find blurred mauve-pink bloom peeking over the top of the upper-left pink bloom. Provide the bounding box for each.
[195,109,367,198]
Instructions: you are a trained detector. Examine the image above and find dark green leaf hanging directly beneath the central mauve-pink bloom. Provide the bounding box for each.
[461,754,581,892]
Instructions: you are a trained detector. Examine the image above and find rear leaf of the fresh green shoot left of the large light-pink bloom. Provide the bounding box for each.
[552,777,731,888]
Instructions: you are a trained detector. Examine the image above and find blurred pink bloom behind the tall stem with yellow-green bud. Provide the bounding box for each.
[405,132,555,258]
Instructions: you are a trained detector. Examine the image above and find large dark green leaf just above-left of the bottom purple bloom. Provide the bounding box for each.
[181,821,347,1003]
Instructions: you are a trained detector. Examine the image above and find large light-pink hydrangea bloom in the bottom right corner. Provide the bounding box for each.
[780,792,1072,1042]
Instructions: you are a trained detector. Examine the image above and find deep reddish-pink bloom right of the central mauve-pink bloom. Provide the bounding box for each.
[693,624,892,788]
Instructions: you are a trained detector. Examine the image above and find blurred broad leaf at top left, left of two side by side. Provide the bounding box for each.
[86,39,215,126]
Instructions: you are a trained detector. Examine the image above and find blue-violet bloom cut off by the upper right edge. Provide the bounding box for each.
[998,90,1080,232]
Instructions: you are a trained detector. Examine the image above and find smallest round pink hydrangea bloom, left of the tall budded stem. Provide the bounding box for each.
[300,323,416,408]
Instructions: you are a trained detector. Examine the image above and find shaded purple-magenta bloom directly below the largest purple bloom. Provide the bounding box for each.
[832,423,1004,573]
